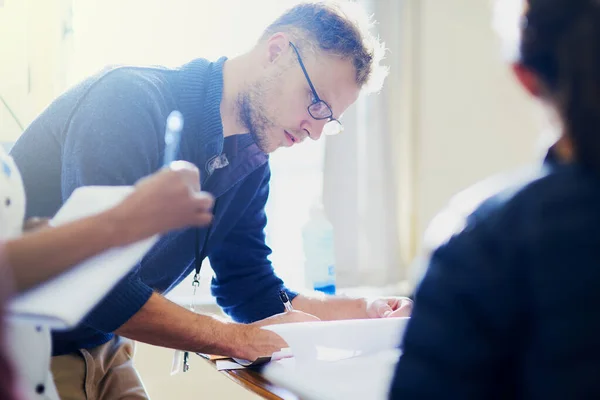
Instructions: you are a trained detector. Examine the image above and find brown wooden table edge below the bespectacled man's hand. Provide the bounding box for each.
[198,354,300,400]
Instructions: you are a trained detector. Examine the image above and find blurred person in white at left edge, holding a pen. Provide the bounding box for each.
[0,150,213,400]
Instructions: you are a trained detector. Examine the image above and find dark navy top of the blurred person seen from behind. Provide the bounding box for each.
[391,154,600,400]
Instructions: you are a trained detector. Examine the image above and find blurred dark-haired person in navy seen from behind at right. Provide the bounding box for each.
[390,0,600,399]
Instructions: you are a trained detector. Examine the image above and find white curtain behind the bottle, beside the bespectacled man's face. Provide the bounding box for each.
[324,0,404,287]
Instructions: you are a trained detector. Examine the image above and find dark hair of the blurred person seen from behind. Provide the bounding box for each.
[520,0,600,173]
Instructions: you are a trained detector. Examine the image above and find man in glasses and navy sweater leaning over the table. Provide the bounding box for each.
[12,2,410,398]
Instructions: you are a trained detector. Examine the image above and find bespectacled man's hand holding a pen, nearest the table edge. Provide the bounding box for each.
[234,310,319,361]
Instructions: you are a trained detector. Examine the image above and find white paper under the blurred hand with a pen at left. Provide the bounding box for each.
[7,186,158,329]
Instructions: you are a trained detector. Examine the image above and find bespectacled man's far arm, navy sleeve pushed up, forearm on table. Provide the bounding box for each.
[209,165,412,322]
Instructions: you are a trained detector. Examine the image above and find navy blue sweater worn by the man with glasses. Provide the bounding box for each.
[11,58,295,355]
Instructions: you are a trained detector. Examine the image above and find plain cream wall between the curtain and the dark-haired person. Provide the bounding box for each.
[412,0,541,248]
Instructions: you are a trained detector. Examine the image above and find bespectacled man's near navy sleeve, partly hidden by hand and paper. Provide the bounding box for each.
[62,70,169,332]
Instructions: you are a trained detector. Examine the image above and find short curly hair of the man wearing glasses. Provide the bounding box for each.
[261,1,387,90]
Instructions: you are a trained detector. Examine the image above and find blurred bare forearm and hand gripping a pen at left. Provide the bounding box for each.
[5,162,212,293]
